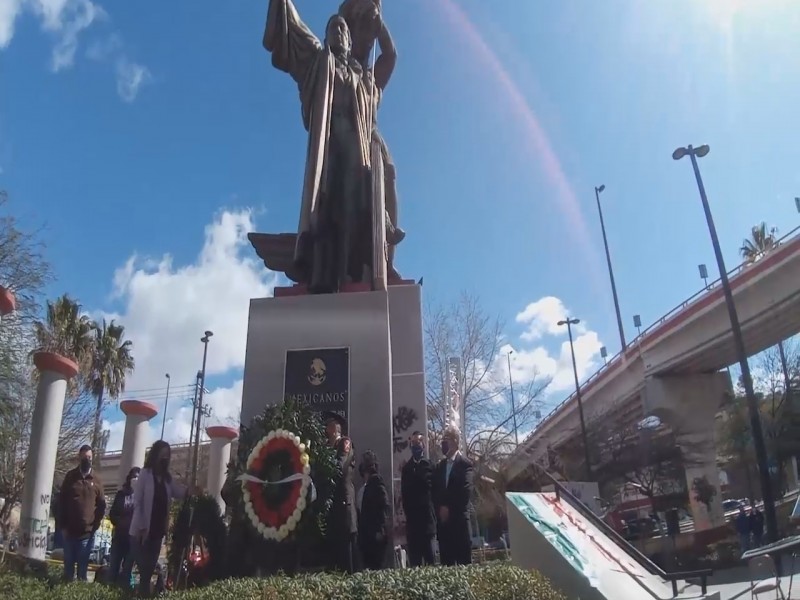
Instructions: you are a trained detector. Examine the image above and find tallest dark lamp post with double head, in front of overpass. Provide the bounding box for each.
[672,145,778,542]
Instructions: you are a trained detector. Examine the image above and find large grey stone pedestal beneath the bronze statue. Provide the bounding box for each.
[241,283,427,561]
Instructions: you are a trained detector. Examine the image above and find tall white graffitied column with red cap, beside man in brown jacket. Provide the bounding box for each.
[19,352,78,560]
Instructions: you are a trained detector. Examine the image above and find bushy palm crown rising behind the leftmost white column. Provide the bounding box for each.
[33,294,94,372]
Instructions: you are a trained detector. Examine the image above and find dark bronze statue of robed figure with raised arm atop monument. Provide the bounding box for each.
[255,0,404,293]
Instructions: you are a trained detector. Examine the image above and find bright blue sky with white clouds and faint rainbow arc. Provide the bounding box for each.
[0,0,800,445]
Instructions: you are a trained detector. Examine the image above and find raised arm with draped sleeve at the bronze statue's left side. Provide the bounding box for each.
[264,0,322,84]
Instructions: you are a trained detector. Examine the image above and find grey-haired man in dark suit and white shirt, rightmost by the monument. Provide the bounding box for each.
[433,425,472,566]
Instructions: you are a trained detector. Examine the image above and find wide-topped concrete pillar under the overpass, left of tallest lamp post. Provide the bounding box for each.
[643,373,732,531]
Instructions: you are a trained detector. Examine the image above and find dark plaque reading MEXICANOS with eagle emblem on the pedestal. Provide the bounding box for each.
[283,348,350,423]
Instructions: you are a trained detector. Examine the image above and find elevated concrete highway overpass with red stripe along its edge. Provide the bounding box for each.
[508,228,800,502]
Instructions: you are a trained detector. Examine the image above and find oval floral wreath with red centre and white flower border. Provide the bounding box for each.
[237,429,316,541]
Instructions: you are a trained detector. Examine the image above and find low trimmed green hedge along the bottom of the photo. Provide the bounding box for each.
[0,565,564,600]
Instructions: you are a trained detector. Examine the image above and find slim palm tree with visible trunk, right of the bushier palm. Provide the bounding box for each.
[87,319,135,447]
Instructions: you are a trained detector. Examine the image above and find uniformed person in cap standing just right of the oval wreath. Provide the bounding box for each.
[325,414,358,573]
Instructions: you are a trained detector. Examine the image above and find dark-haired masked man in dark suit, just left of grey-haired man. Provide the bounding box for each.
[400,431,436,567]
